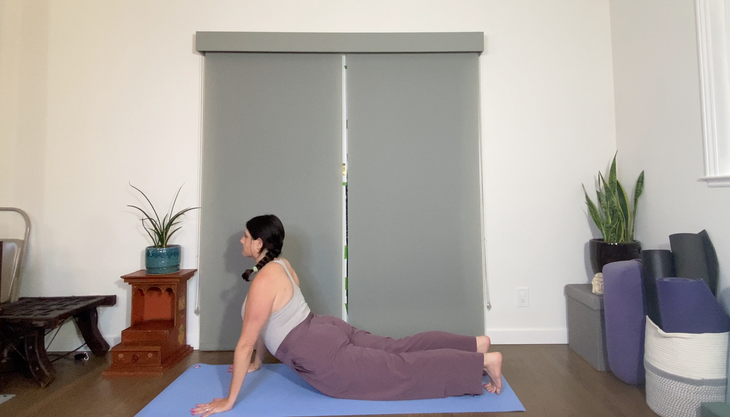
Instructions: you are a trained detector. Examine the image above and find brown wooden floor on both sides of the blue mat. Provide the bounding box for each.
[0,345,656,417]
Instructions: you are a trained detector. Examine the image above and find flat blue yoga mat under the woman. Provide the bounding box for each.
[137,364,525,417]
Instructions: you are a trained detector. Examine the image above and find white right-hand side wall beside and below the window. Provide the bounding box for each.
[611,0,730,311]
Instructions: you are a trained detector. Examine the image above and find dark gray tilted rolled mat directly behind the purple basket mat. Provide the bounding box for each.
[669,230,719,294]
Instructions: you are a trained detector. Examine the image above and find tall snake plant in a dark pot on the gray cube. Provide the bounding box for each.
[583,154,644,274]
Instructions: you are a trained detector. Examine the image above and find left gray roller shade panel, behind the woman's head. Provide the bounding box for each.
[199,53,342,350]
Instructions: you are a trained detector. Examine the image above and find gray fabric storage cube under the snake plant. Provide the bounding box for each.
[565,284,608,371]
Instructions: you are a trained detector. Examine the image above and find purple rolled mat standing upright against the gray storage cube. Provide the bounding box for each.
[603,259,646,384]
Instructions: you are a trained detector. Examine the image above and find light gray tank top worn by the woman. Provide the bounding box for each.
[241,259,311,355]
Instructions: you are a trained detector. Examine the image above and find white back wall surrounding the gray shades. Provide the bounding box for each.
[0,0,616,350]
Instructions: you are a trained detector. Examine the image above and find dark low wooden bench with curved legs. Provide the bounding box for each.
[0,295,117,387]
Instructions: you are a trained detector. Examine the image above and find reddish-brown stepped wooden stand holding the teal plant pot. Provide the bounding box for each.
[102,269,197,376]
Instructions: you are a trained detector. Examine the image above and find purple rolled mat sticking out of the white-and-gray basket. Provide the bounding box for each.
[657,278,730,333]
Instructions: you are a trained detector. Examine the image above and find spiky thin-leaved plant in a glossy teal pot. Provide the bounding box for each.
[128,184,200,274]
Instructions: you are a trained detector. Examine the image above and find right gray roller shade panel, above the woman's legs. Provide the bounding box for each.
[347,53,484,337]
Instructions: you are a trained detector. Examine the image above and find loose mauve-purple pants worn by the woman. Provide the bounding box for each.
[274,314,484,400]
